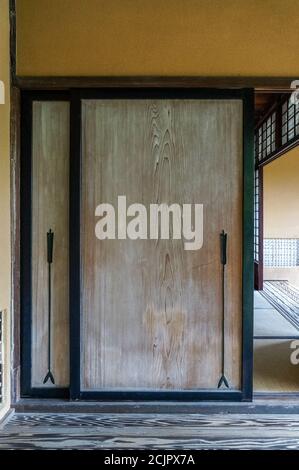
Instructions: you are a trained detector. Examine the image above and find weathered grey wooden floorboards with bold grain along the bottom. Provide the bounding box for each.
[0,413,299,450]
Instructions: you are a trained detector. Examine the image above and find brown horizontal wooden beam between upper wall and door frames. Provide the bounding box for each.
[14,76,298,93]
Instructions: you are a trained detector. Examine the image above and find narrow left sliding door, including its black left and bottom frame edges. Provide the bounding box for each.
[21,93,70,397]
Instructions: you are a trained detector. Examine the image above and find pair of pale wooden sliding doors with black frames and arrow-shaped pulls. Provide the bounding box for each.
[21,89,253,400]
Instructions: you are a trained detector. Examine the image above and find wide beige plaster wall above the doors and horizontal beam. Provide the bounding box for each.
[16,0,299,77]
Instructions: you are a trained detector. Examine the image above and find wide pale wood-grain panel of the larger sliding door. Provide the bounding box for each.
[81,100,242,390]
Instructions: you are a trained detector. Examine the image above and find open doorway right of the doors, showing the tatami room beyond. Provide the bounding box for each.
[254,93,299,395]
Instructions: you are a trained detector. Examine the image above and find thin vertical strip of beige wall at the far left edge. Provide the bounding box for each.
[0,0,10,418]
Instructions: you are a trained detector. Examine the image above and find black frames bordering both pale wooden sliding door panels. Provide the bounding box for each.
[17,89,253,401]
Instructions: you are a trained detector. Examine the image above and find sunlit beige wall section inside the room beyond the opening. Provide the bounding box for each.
[264,147,299,238]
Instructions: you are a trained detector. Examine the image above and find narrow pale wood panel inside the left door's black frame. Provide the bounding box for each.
[32,101,69,387]
